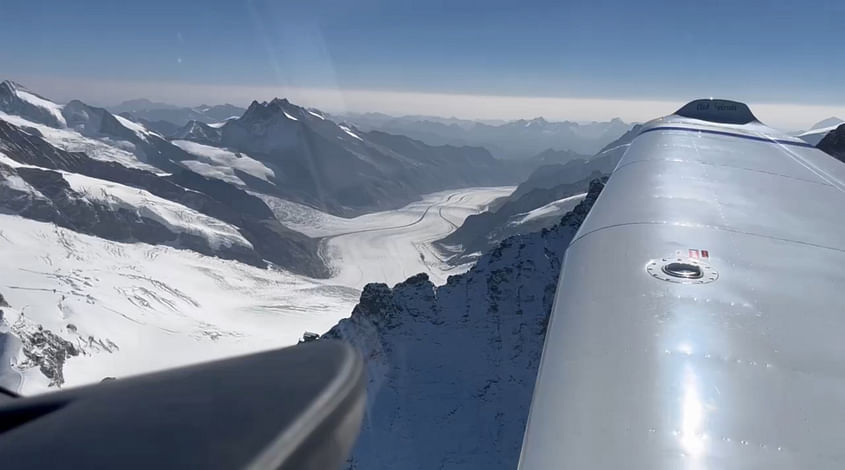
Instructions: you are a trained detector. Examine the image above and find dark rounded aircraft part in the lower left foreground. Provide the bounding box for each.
[0,341,364,470]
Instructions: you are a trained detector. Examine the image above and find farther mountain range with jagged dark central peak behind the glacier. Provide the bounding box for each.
[0,82,526,216]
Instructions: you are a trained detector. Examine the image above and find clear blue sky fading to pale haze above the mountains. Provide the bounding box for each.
[0,0,845,126]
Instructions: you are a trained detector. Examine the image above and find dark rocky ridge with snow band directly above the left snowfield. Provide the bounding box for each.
[0,114,327,276]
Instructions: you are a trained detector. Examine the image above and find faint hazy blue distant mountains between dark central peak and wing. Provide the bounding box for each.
[342,113,631,159]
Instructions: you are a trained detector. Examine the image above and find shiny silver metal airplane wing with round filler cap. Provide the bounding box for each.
[519,100,845,470]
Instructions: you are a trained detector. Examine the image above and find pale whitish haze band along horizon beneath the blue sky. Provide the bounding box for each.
[8,76,845,131]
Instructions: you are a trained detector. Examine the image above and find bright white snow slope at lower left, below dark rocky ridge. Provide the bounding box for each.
[0,215,358,394]
